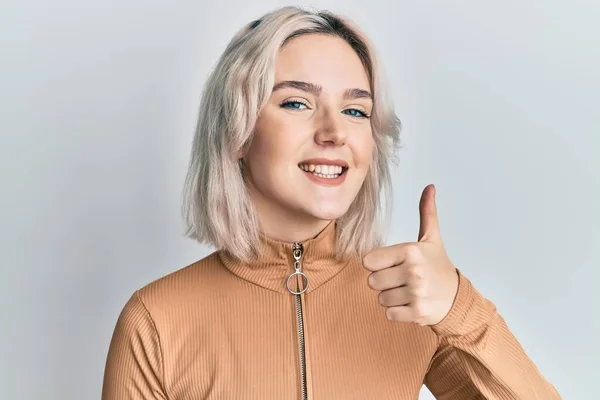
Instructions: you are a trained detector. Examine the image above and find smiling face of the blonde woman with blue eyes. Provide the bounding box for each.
[244,34,373,236]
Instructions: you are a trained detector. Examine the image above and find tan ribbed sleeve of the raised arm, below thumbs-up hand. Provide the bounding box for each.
[425,270,561,400]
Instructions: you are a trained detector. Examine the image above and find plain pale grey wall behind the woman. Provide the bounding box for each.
[0,0,600,400]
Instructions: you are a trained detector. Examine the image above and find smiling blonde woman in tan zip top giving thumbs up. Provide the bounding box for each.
[102,7,560,400]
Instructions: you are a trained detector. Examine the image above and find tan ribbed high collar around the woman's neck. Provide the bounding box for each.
[219,221,348,294]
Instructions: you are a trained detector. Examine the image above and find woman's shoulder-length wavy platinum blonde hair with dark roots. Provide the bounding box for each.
[182,7,400,260]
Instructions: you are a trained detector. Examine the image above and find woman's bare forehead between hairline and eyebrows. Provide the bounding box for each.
[275,34,370,93]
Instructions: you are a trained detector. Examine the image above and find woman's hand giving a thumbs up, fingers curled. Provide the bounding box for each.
[363,185,458,326]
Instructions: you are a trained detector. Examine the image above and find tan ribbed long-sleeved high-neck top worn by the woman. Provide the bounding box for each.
[102,223,560,400]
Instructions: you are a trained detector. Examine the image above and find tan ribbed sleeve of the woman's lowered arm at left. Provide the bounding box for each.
[102,292,167,400]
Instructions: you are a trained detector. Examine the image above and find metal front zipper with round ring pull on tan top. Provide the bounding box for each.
[285,243,308,400]
